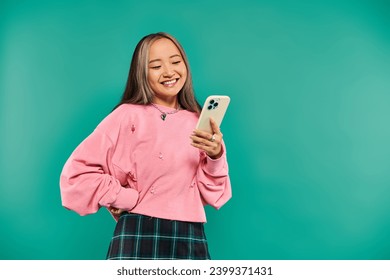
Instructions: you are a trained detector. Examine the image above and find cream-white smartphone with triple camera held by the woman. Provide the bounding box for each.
[196,95,230,133]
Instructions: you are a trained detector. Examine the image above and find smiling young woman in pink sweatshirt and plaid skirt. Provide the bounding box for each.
[60,33,231,260]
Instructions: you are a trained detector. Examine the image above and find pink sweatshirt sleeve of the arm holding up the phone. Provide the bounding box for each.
[196,144,232,209]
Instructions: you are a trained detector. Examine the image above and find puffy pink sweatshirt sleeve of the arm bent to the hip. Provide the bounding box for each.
[60,129,138,216]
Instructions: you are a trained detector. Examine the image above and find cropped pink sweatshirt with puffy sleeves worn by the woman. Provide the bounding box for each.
[60,104,231,222]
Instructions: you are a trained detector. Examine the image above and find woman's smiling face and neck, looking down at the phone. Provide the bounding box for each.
[148,38,187,106]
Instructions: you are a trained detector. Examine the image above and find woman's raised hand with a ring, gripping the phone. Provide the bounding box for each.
[190,118,223,159]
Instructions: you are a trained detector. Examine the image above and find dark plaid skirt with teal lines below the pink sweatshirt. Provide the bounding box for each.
[107,212,210,260]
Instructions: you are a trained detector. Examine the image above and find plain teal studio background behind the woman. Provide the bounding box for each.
[0,0,390,259]
